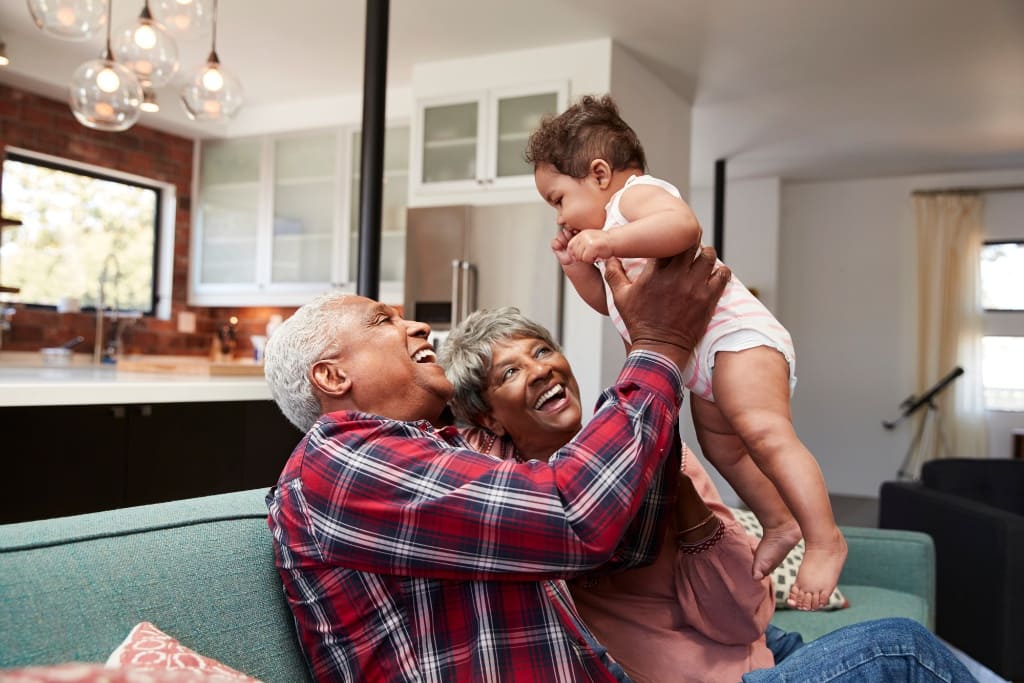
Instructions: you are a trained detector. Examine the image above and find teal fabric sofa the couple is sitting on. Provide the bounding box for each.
[0,489,935,683]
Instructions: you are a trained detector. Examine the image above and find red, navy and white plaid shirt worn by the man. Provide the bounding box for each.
[267,351,682,683]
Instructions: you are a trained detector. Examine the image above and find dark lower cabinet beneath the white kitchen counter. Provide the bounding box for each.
[0,400,302,523]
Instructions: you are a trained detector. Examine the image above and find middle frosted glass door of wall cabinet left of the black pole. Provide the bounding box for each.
[270,132,339,284]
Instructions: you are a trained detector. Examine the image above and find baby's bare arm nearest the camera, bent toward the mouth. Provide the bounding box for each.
[568,184,700,263]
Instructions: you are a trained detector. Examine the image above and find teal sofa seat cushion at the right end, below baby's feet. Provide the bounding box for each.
[771,584,930,642]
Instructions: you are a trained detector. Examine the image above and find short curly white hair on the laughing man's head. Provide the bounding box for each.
[263,292,348,432]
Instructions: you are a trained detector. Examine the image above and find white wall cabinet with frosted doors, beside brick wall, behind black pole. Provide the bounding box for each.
[189,127,409,306]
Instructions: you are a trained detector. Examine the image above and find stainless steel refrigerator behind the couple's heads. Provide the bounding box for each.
[403,202,563,346]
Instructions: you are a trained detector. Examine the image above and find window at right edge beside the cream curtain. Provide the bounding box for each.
[981,241,1024,412]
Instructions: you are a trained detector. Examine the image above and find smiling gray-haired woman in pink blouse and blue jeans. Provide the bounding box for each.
[440,308,976,683]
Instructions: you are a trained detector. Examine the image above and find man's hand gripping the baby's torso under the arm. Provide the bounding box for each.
[604,247,732,369]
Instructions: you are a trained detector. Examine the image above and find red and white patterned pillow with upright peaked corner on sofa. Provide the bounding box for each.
[106,622,260,683]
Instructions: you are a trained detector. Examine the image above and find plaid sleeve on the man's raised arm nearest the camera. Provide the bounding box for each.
[292,351,682,581]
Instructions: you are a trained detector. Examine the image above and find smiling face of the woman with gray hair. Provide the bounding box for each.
[481,337,583,460]
